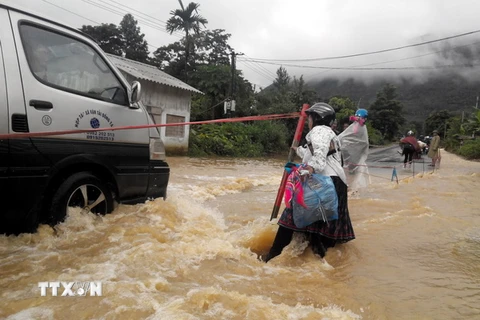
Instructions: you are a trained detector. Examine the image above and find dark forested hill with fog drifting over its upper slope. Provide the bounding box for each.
[306,37,480,121]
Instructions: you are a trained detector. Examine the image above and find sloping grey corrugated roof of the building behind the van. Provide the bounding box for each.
[107,53,203,94]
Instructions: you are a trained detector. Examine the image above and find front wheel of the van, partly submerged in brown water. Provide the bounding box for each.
[49,172,113,224]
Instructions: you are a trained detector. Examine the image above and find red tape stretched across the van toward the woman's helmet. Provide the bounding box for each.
[0,112,300,139]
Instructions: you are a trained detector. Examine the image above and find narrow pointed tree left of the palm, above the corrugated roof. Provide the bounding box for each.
[119,13,149,63]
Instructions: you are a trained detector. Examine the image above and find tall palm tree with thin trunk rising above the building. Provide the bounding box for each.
[166,0,208,82]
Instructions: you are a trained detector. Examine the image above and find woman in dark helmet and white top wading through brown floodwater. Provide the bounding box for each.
[261,103,355,262]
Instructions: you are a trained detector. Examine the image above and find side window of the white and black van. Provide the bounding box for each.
[20,24,128,105]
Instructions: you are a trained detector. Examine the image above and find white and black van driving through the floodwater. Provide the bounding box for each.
[0,4,170,234]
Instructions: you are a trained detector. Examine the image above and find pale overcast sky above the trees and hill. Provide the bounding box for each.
[0,0,480,87]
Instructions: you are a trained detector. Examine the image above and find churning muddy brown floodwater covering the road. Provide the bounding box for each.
[0,147,480,319]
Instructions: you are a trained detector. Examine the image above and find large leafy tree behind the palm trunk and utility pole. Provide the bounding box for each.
[154,25,256,121]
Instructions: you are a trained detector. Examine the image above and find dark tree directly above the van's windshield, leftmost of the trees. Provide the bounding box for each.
[80,23,124,56]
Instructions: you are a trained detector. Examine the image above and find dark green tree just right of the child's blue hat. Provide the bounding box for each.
[368,84,405,140]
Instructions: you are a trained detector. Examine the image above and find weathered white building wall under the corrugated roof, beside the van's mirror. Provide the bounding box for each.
[122,72,192,155]
